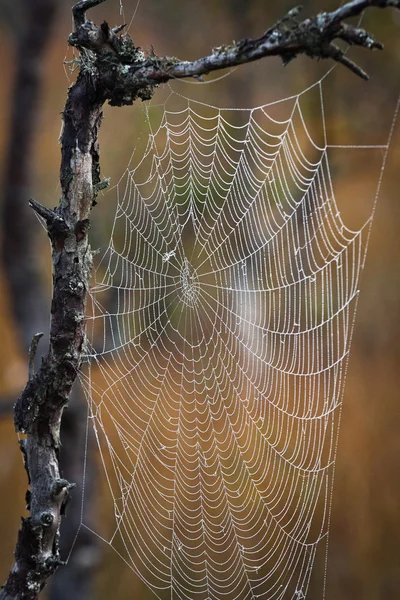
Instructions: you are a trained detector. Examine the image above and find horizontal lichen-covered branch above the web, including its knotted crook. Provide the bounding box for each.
[69,0,400,106]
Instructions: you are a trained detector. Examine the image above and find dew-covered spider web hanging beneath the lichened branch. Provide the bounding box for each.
[78,76,396,600]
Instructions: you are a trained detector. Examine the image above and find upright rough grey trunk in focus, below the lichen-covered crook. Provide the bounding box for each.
[0,2,104,599]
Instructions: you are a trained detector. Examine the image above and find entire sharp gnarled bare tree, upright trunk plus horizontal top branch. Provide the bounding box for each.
[0,0,400,600]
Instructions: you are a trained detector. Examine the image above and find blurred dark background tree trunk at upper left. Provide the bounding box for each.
[2,0,58,344]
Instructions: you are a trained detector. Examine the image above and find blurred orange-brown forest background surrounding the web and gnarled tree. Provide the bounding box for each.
[0,0,400,600]
